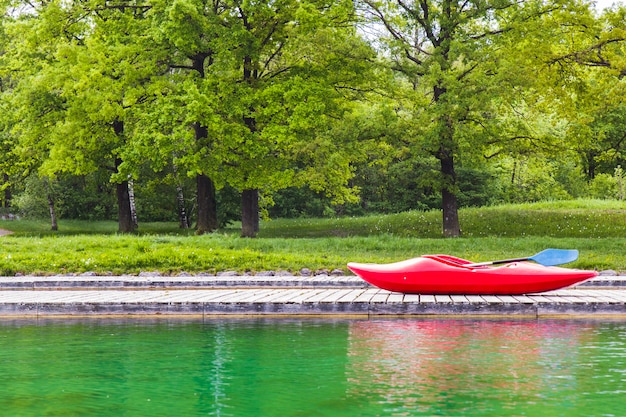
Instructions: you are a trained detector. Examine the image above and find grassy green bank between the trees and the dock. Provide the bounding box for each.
[0,201,626,275]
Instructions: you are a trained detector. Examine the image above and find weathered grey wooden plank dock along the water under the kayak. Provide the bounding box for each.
[0,276,626,318]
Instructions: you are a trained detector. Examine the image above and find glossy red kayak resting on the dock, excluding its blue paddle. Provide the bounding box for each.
[348,255,598,295]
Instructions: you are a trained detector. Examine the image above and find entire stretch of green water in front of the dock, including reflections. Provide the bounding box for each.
[0,319,626,417]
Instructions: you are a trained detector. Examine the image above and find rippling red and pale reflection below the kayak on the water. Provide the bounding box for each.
[347,320,626,416]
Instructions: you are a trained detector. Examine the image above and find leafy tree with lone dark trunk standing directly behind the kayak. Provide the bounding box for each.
[363,0,592,237]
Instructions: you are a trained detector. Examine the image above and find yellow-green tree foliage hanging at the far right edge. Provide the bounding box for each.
[551,7,626,181]
